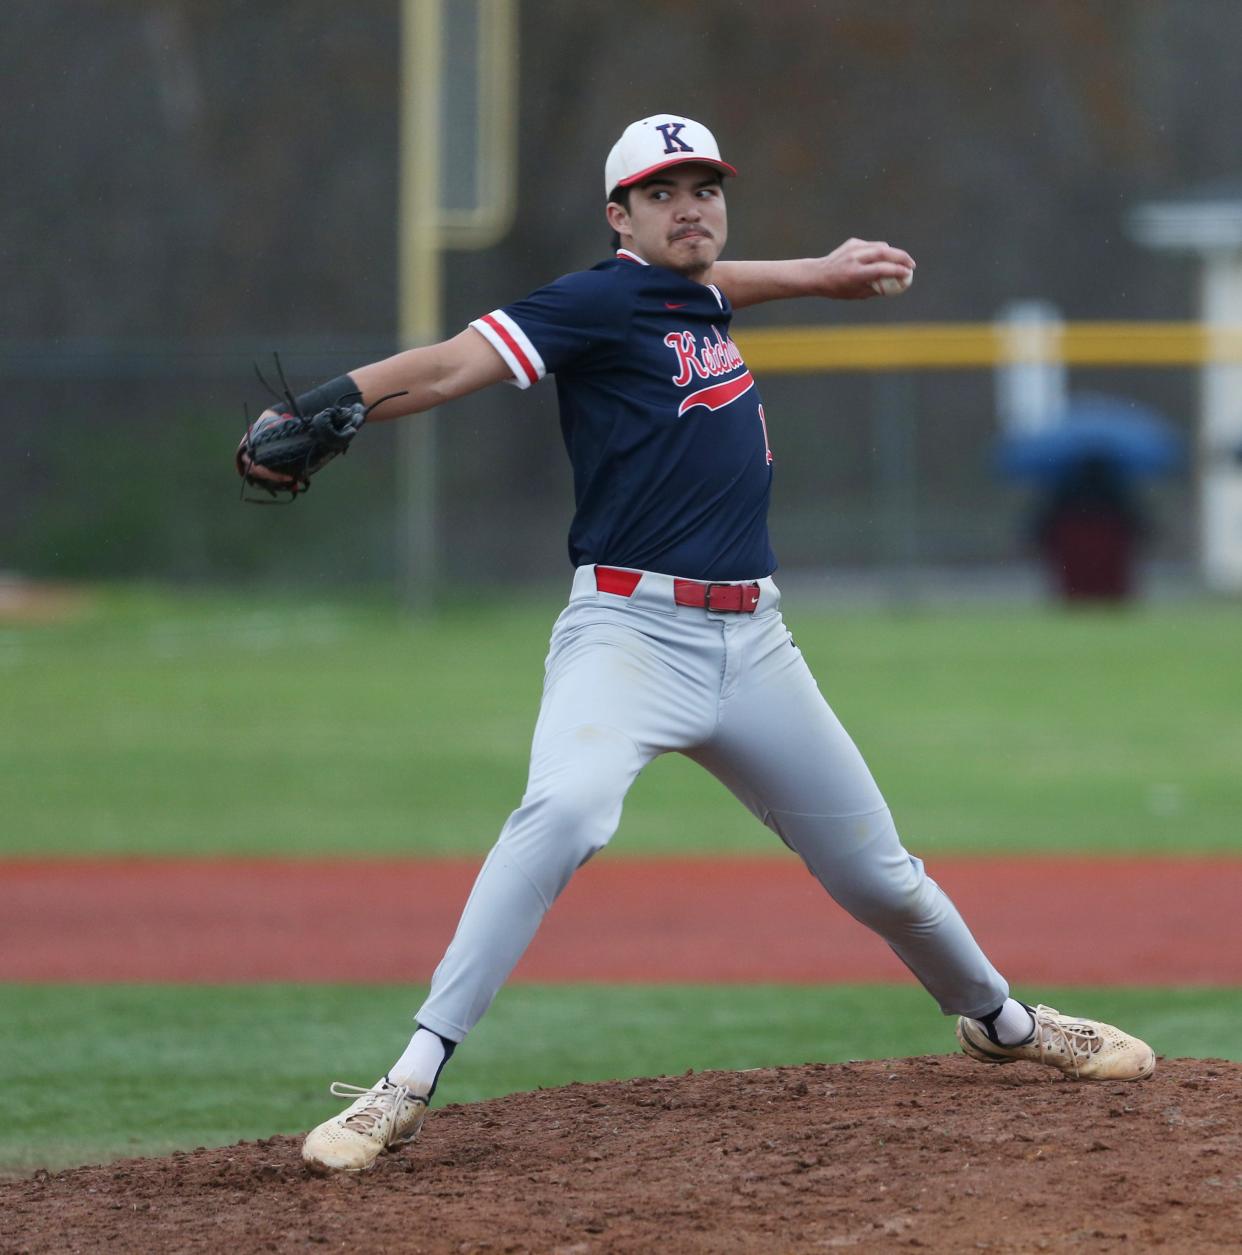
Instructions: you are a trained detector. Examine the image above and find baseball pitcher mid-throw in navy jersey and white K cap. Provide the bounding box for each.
[237,114,1154,1172]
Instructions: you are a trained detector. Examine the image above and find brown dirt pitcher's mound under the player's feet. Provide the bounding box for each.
[0,1057,1242,1255]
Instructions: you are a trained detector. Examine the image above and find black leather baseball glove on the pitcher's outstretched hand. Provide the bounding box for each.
[233,399,366,499]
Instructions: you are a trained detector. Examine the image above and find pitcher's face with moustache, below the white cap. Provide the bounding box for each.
[608,164,729,279]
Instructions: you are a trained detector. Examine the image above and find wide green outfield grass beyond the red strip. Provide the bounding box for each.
[0,591,1242,855]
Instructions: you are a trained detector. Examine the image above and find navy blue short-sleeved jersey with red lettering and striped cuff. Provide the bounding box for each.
[470,250,777,580]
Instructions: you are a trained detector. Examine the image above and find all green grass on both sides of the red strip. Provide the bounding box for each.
[0,590,1242,1172]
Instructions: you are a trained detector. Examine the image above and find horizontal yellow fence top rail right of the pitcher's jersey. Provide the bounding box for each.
[735,323,1242,374]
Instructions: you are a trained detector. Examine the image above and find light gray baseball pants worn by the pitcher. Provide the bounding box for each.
[417,566,1009,1042]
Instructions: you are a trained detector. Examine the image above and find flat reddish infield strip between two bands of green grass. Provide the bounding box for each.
[0,856,1242,985]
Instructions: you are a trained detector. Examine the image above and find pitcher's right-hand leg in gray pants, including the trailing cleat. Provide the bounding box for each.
[690,594,1154,1079]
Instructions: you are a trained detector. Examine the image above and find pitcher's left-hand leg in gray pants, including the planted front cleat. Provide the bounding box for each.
[302,569,719,1171]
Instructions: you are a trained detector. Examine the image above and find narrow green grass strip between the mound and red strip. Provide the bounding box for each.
[0,985,1242,1173]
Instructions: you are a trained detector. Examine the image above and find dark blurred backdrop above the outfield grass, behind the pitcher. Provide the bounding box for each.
[0,0,1242,582]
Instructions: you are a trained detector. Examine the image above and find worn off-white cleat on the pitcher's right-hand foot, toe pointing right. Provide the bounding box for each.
[957,1007,1155,1081]
